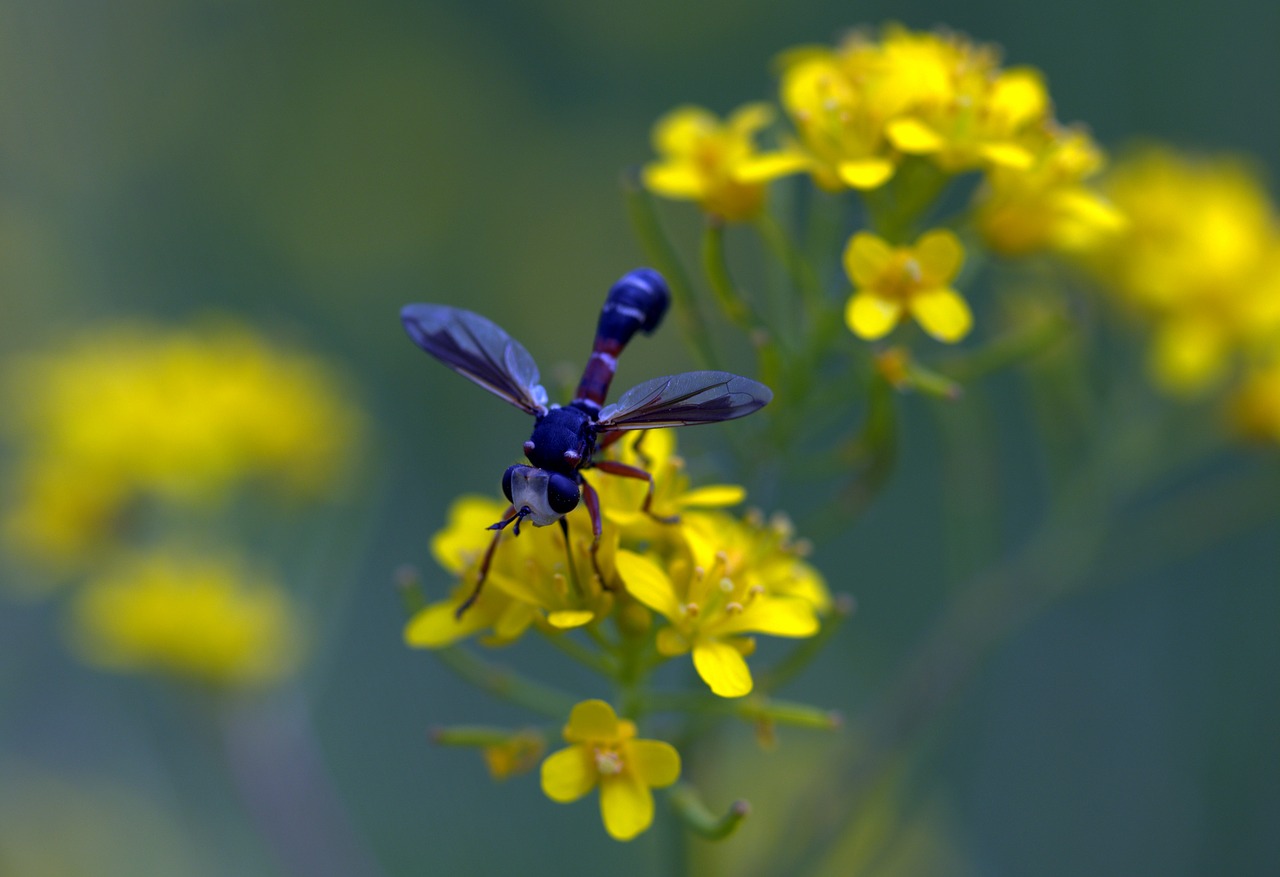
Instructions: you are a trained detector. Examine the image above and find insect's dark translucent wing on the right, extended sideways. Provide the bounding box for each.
[596,371,773,433]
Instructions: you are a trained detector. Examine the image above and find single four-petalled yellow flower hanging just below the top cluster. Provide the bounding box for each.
[845,229,973,342]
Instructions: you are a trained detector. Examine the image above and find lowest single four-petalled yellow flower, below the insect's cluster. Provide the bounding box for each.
[541,700,680,840]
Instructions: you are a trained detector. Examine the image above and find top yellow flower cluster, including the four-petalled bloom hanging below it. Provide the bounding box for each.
[644,26,1124,343]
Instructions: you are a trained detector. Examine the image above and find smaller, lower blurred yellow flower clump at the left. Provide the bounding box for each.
[72,549,301,685]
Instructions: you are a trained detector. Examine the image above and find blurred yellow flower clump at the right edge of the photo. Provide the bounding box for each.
[1087,147,1280,393]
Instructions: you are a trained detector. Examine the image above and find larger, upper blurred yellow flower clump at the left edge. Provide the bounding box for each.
[4,324,361,571]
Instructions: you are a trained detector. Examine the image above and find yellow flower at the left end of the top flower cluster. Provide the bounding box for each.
[644,104,805,220]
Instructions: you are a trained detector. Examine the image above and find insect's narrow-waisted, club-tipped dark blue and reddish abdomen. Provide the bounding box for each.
[571,268,671,414]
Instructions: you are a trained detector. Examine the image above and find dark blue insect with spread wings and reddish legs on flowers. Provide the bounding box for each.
[401,268,773,617]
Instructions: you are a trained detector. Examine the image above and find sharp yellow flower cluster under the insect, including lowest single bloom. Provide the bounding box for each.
[404,430,832,840]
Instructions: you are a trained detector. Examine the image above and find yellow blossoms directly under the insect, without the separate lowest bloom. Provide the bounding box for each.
[404,430,831,698]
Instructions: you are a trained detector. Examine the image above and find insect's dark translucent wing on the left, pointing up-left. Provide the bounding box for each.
[401,305,547,415]
